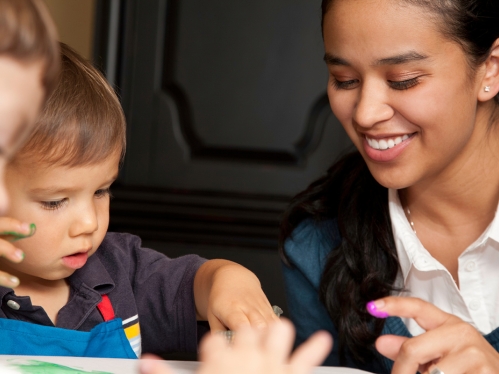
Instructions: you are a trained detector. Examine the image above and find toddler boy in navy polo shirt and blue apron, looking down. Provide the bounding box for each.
[0,45,277,358]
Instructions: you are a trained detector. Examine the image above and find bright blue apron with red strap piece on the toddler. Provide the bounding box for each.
[0,295,137,358]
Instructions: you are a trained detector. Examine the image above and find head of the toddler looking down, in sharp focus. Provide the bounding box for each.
[2,45,126,285]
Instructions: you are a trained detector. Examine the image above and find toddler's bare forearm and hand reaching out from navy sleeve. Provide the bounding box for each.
[194,260,278,332]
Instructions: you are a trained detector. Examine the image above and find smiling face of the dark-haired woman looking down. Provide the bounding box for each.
[324,2,484,189]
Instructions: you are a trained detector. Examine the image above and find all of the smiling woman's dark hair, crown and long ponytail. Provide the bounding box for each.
[279,0,499,362]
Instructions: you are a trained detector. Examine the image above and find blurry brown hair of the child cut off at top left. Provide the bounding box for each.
[0,0,60,95]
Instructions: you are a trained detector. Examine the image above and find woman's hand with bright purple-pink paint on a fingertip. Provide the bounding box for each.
[373,297,499,374]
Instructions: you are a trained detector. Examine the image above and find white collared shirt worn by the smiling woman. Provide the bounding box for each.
[388,189,499,336]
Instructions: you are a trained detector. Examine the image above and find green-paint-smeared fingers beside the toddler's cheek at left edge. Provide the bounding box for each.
[0,217,34,287]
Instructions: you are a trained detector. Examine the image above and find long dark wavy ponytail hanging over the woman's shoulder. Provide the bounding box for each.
[280,152,398,361]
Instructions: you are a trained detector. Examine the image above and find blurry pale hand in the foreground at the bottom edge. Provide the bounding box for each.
[140,320,332,374]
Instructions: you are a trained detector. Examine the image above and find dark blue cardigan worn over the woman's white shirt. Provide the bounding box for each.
[283,220,499,373]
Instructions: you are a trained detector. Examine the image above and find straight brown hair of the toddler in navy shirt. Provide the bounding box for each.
[13,43,126,167]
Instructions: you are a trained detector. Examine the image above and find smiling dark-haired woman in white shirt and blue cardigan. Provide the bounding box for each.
[281,0,499,373]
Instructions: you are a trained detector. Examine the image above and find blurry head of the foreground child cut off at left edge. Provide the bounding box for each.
[0,0,59,213]
